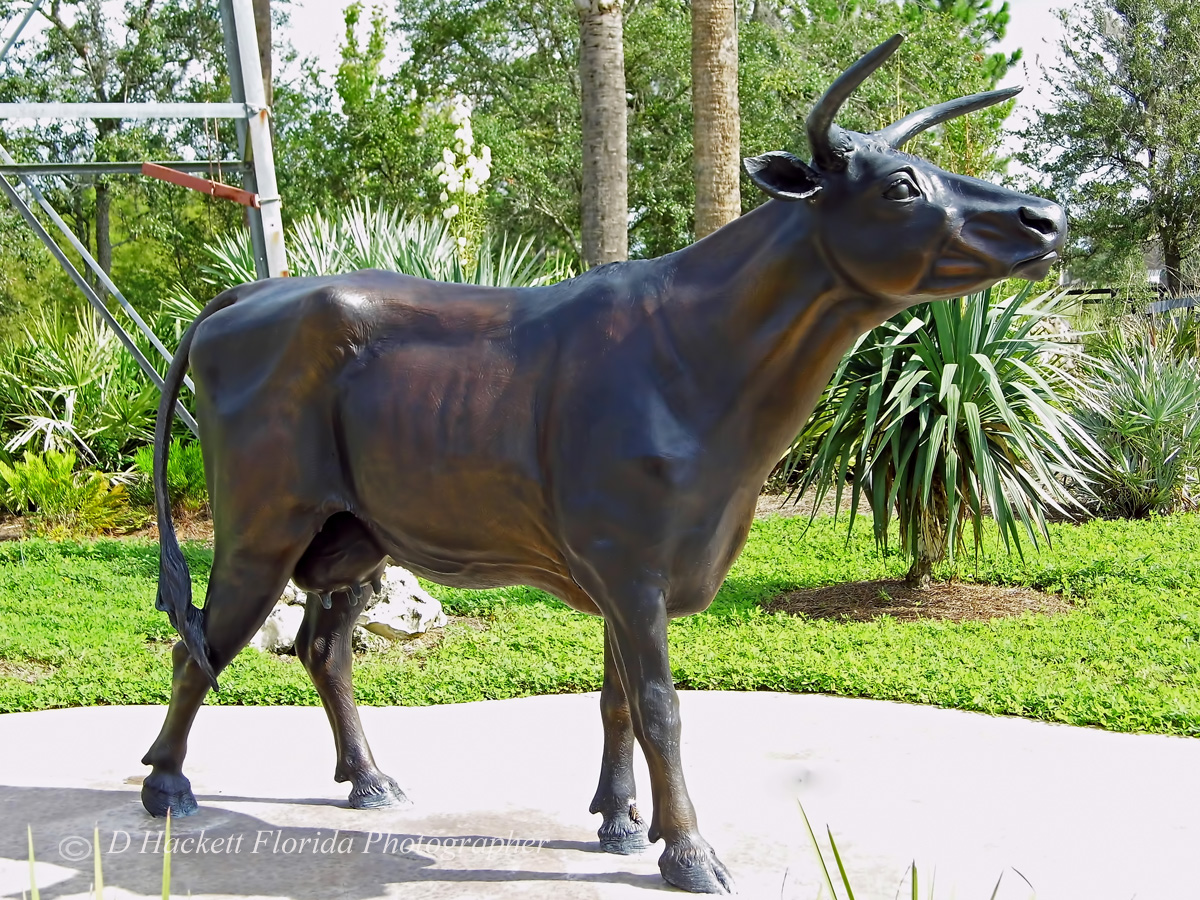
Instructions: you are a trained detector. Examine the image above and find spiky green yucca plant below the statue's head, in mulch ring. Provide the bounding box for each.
[788,289,1092,586]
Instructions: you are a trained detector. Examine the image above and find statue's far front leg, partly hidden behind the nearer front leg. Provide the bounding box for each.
[589,623,649,853]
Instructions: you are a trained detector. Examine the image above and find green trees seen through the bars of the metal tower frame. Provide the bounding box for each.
[0,0,240,321]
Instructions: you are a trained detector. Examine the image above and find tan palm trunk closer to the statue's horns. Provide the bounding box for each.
[691,0,742,240]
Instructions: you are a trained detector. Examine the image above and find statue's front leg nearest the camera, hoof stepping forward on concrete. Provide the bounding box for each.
[601,586,733,894]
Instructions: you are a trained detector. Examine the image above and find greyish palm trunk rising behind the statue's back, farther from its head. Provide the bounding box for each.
[575,0,629,265]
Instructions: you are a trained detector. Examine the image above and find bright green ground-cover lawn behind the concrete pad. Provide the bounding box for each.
[0,515,1200,736]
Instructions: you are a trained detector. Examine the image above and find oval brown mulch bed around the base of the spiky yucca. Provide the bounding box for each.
[764,580,1072,622]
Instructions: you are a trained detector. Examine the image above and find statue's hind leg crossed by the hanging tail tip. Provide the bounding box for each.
[142,545,304,816]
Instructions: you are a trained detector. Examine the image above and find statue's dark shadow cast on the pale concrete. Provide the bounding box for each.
[0,785,671,900]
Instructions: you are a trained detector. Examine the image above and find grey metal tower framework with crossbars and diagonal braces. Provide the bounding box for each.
[0,0,288,433]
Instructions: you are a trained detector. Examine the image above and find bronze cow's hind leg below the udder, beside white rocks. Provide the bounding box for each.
[296,590,409,809]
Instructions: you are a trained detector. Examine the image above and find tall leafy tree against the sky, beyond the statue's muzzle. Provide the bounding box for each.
[1020,0,1200,290]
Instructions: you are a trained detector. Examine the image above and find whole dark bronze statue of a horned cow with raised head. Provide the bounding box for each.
[142,36,1066,893]
